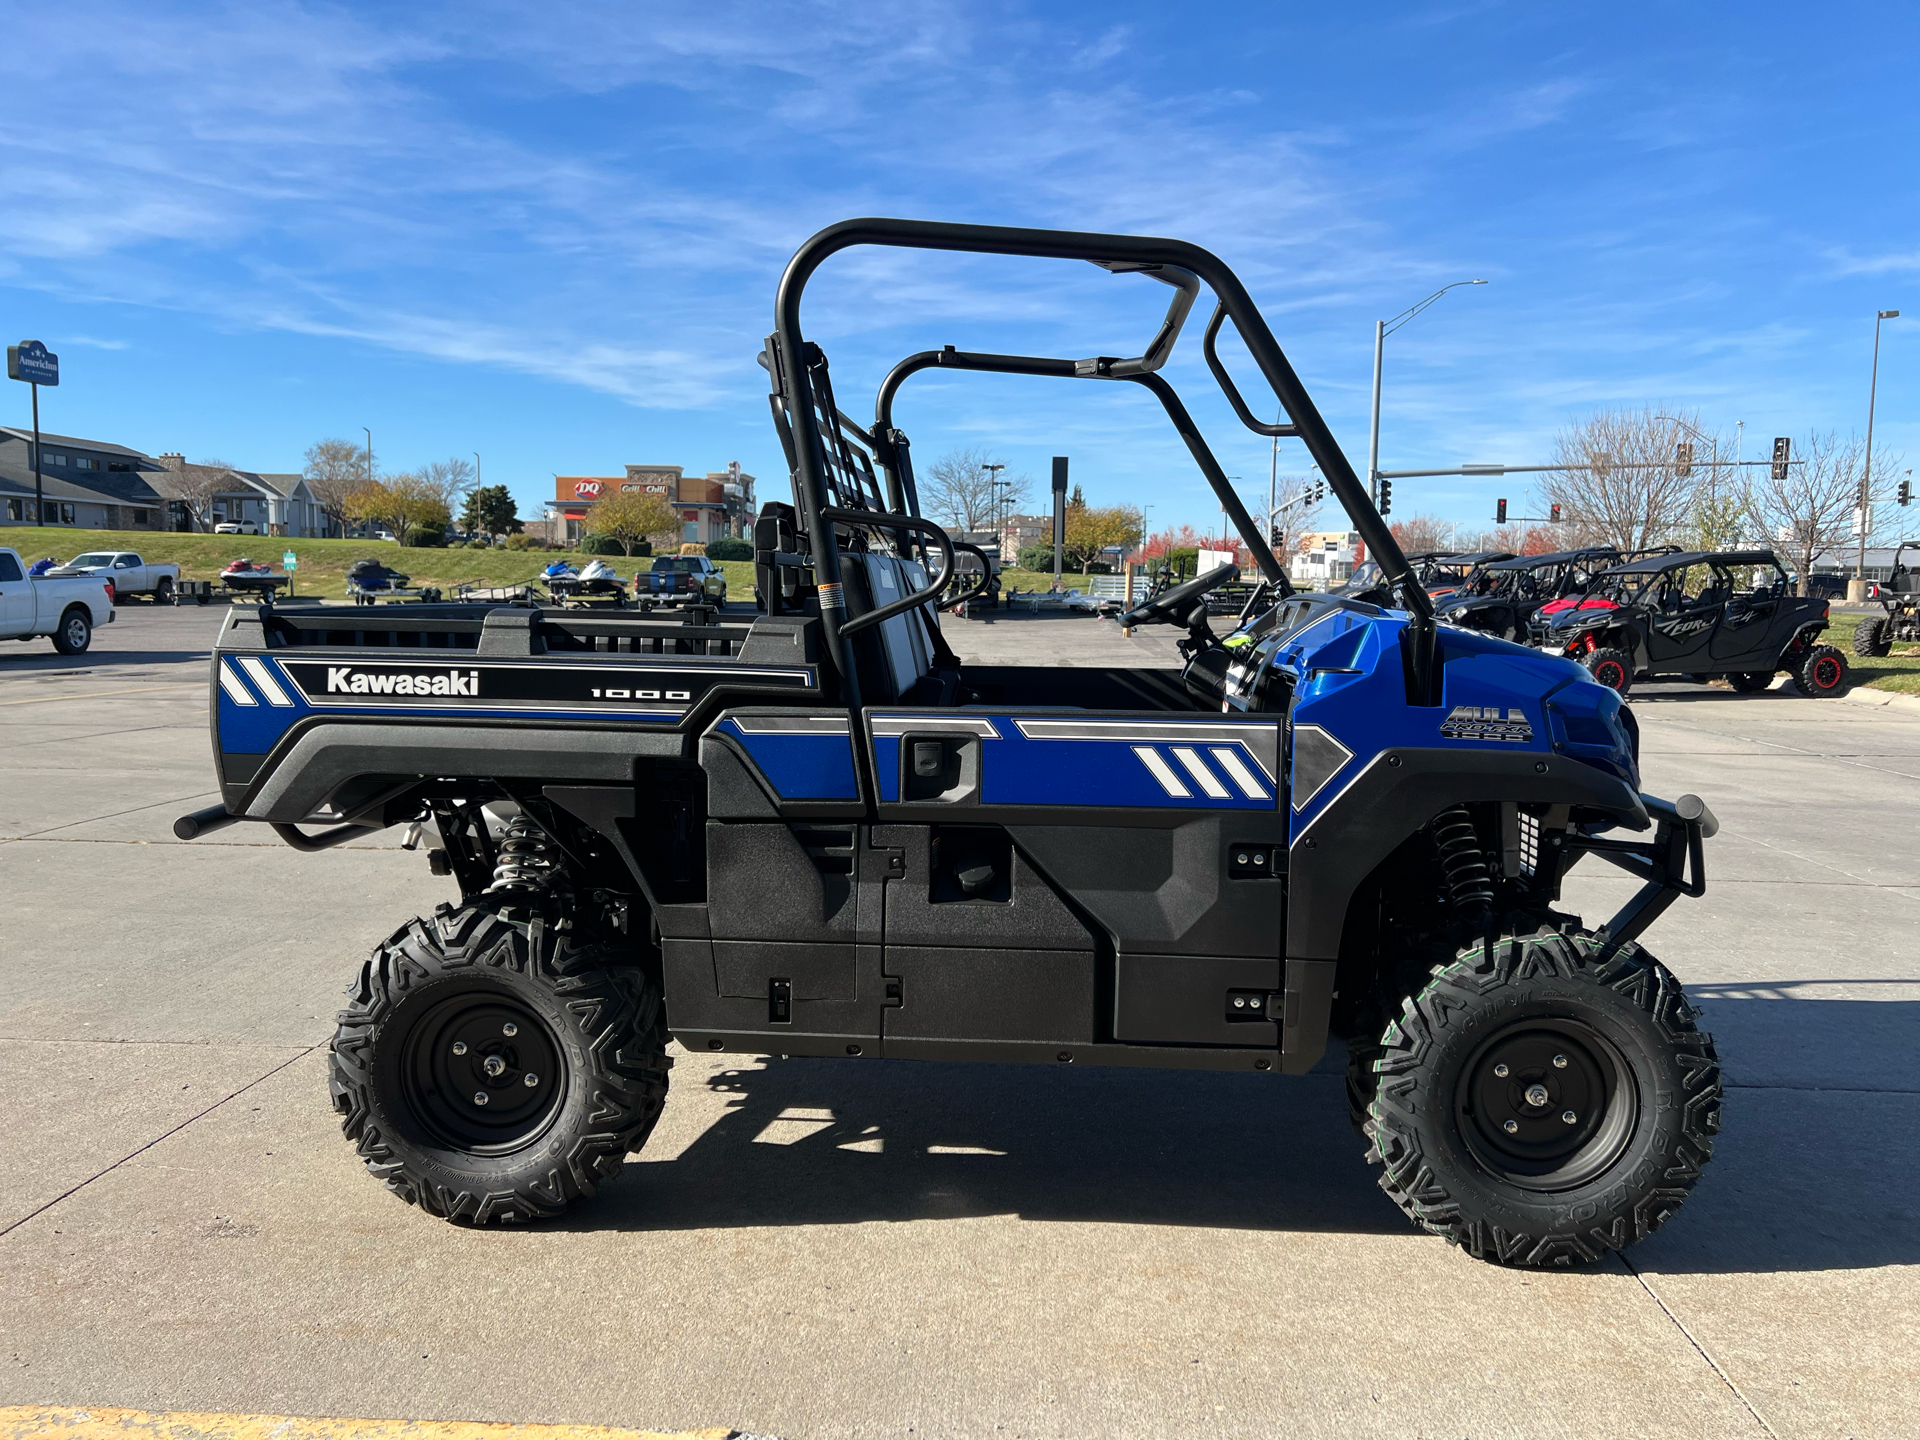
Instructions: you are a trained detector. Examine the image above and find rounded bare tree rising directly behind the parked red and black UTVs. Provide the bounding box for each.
[1540,409,1695,549]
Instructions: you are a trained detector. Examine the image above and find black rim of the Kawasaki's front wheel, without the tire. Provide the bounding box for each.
[1453,1020,1640,1190]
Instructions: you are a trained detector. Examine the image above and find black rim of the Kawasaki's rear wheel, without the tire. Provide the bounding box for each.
[399,985,566,1156]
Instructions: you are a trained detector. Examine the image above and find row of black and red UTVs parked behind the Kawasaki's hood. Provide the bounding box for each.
[1348,545,1850,697]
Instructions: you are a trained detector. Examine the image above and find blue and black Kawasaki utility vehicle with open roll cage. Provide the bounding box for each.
[177,219,1720,1265]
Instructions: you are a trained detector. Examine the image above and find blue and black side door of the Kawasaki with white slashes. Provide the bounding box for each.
[868,707,1286,1048]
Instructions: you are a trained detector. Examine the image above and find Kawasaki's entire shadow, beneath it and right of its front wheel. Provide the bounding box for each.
[557,983,1920,1275]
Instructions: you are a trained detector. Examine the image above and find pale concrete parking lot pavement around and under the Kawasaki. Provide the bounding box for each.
[0,607,1920,1440]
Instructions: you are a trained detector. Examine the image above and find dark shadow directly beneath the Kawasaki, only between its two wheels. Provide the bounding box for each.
[559,1060,1405,1233]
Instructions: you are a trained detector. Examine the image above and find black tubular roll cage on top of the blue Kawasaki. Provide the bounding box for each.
[764,217,1436,710]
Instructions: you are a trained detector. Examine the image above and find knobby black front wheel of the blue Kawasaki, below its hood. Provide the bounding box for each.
[1361,931,1720,1265]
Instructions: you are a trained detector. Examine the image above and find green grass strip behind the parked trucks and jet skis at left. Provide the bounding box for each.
[0,526,753,601]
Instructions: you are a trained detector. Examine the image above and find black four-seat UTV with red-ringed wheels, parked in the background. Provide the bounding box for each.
[1546,549,1847,697]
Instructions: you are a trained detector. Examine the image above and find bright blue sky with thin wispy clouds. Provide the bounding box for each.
[0,0,1920,528]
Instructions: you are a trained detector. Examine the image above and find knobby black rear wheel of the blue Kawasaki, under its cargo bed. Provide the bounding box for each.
[330,899,668,1225]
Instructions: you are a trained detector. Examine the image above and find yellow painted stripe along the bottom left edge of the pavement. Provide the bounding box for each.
[0,1405,737,1440]
